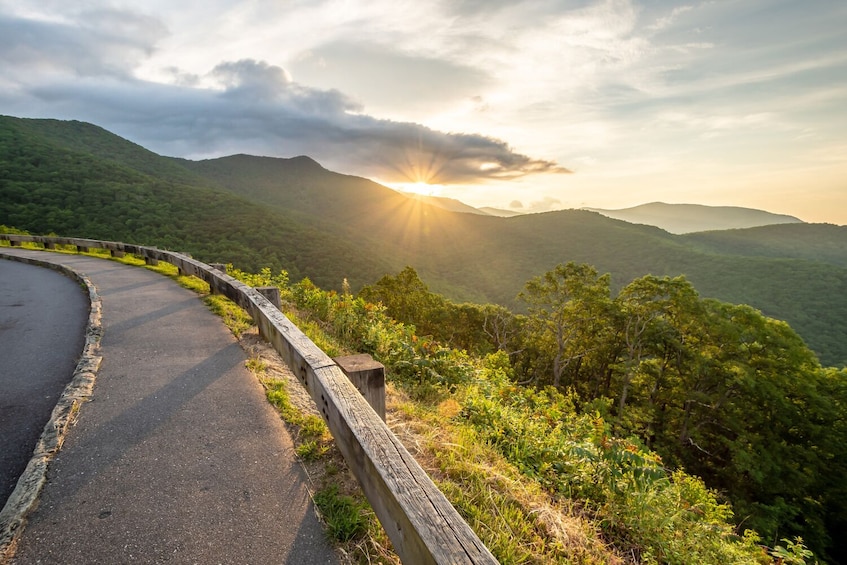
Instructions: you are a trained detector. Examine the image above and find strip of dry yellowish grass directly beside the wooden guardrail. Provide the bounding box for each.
[386,386,626,564]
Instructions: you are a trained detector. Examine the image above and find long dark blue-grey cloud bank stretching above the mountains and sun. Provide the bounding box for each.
[0,11,564,184]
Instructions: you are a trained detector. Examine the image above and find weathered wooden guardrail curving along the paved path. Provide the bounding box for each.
[0,234,497,565]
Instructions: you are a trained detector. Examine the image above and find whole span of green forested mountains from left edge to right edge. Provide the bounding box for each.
[0,117,847,365]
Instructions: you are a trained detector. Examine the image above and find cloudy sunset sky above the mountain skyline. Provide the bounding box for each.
[0,0,847,225]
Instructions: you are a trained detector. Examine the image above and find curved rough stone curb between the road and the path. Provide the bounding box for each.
[0,251,103,563]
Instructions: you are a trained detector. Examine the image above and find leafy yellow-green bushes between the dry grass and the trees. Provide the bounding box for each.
[462,353,769,563]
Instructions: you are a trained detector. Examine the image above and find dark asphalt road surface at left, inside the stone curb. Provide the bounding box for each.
[0,261,88,508]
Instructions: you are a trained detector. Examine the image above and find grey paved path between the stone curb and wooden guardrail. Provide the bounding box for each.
[0,250,337,565]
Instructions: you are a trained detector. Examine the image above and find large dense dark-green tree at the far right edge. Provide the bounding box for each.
[656,300,845,556]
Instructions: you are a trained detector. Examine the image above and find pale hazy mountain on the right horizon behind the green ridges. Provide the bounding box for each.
[584,202,803,234]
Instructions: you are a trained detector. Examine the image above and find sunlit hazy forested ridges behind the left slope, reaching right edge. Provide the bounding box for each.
[188,150,847,365]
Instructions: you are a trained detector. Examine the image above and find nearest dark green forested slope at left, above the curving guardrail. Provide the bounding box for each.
[0,118,394,286]
